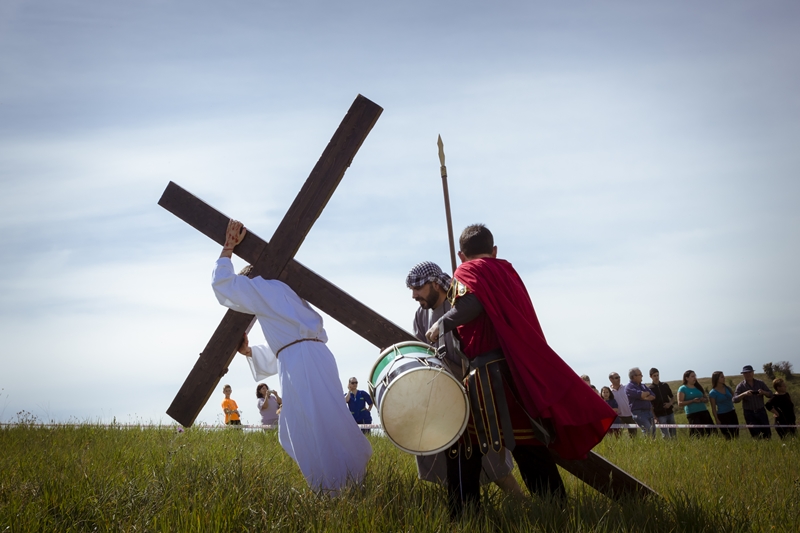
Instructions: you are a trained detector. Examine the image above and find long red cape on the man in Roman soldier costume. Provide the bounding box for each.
[453,258,617,459]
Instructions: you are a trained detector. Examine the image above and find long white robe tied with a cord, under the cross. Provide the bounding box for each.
[212,258,372,493]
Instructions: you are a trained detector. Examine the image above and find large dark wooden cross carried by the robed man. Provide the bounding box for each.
[158,95,656,498]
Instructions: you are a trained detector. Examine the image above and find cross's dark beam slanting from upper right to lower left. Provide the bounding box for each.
[167,95,383,426]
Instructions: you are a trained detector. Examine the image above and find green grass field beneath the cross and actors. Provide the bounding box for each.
[0,424,800,533]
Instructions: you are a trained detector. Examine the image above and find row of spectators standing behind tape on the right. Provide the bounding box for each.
[581,365,796,440]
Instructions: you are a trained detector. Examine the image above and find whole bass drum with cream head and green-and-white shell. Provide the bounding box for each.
[369,341,469,455]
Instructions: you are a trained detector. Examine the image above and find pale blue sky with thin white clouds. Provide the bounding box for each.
[0,0,800,423]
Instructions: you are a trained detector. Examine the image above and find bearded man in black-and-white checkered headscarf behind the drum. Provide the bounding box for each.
[406,261,522,494]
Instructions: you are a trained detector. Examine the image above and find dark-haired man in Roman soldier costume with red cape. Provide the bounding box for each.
[428,224,616,512]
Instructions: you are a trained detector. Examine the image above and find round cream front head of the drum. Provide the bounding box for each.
[380,367,469,455]
